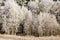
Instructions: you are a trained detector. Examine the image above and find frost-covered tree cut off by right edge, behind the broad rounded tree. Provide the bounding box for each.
[50,2,60,23]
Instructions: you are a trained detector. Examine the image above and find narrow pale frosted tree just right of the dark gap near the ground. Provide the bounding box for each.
[24,11,32,35]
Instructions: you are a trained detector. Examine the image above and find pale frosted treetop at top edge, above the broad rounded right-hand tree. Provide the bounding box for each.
[39,0,54,12]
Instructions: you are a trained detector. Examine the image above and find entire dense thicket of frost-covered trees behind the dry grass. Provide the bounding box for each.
[0,0,60,36]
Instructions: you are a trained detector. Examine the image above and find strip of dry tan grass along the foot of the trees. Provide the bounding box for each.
[0,35,60,40]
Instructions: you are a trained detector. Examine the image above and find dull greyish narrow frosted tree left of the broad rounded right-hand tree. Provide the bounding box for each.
[31,14,39,36]
